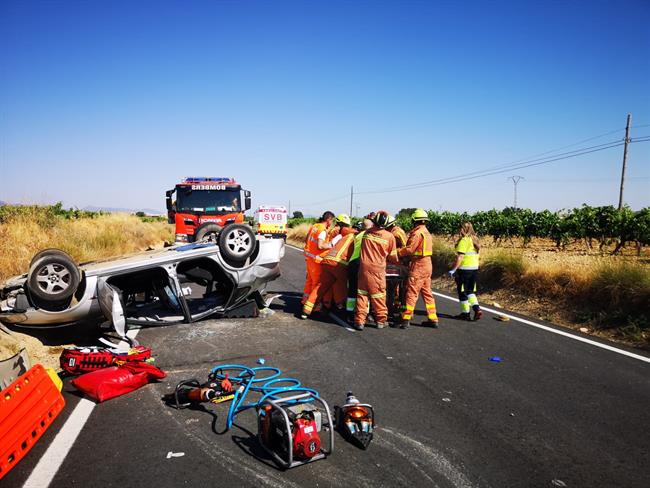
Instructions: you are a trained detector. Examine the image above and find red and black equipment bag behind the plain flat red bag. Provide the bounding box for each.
[59,346,151,374]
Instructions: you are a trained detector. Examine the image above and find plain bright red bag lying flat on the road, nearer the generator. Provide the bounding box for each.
[72,362,167,402]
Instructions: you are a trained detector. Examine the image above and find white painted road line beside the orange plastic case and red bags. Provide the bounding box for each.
[23,329,140,488]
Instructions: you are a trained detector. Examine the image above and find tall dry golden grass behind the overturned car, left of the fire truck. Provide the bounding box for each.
[0,209,174,281]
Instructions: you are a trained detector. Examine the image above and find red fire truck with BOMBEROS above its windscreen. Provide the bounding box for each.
[165,177,251,242]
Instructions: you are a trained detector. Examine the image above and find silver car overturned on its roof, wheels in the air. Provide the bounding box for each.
[0,224,284,336]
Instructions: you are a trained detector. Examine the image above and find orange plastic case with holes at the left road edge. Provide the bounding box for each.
[0,364,65,479]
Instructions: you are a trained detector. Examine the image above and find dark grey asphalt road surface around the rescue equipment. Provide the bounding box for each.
[5,248,650,488]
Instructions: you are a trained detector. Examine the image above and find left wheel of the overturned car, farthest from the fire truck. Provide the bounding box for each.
[27,249,81,310]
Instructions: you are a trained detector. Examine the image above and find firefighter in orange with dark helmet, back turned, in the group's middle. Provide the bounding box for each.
[353,211,399,330]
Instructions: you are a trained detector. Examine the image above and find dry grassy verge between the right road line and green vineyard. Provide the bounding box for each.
[434,236,650,348]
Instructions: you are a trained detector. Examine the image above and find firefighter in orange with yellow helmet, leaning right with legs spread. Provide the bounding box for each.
[300,214,356,319]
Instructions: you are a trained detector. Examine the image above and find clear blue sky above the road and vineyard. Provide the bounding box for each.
[0,0,650,214]
